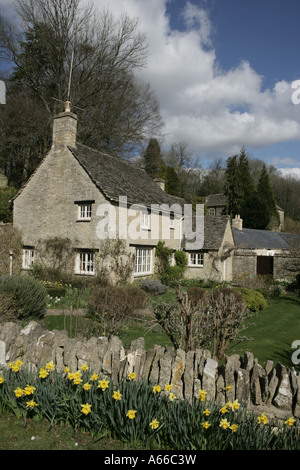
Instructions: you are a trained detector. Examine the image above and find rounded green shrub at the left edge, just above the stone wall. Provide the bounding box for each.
[0,276,47,319]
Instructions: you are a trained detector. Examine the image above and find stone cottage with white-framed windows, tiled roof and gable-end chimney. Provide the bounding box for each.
[13,102,233,278]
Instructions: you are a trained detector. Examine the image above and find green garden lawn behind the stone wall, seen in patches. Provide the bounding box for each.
[44,292,300,370]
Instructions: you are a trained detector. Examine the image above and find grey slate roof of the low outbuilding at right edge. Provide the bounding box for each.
[232,227,300,250]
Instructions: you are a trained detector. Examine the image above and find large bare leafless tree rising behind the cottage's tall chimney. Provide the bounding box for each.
[0,0,162,184]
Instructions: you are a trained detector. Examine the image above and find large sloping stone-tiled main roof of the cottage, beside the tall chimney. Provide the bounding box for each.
[69,143,184,208]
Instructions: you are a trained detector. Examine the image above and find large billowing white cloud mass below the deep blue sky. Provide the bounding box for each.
[95,0,300,158]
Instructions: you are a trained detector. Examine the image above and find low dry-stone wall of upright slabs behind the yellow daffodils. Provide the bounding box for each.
[0,322,300,418]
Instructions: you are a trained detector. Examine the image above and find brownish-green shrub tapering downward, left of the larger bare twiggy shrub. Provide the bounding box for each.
[88,286,147,336]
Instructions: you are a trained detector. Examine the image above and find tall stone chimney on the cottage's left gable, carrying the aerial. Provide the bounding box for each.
[52,101,77,150]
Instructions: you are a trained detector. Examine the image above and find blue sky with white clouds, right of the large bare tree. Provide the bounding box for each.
[0,0,300,176]
